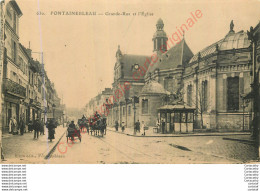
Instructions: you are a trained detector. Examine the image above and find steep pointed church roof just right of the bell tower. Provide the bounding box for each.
[146,39,193,75]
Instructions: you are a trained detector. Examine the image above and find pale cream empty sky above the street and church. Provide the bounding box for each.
[13,0,260,108]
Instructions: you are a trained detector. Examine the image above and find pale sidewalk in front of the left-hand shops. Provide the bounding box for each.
[2,126,67,163]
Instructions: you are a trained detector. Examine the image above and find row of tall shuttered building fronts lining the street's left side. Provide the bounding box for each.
[1,0,65,133]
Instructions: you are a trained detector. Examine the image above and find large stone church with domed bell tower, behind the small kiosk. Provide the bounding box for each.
[87,19,258,131]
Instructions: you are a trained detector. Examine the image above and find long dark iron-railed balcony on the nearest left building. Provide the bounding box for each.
[3,79,26,99]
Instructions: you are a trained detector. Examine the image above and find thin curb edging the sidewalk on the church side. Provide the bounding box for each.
[107,129,250,137]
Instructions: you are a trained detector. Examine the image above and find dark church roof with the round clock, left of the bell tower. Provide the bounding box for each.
[120,54,149,79]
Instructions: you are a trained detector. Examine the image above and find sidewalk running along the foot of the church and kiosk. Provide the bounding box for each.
[107,127,250,137]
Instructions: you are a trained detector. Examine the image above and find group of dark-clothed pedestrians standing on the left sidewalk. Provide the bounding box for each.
[9,117,57,141]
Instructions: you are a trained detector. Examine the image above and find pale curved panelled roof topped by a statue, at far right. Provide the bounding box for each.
[189,31,250,63]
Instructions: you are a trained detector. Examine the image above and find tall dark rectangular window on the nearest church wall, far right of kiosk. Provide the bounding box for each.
[227,76,239,111]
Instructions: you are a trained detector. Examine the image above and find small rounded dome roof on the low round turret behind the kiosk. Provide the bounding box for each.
[141,80,170,95]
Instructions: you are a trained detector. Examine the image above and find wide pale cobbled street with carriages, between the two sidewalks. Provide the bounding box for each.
[44,128,257,164]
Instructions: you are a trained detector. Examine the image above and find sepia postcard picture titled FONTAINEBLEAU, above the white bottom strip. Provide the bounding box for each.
[0,0,260,164]
